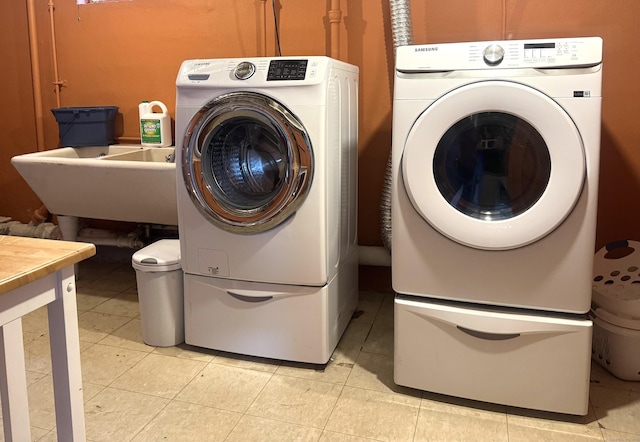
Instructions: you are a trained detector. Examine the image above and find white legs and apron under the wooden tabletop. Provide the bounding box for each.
[0,265,86,441]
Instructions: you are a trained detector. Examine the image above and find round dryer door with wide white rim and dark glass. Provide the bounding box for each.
[402,81,585,250]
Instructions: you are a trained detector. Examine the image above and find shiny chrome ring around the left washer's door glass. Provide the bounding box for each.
[180,92,314,234]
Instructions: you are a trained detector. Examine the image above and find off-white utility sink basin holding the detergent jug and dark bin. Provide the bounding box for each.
[11,145,178,225]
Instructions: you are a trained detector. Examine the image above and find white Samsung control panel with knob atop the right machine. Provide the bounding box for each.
[396,37,602,73]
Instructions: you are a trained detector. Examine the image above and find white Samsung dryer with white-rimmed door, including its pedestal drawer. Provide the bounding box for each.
[392,37,602,414]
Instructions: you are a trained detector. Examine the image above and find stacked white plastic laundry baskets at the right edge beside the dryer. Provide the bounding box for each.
[591,240,640,381]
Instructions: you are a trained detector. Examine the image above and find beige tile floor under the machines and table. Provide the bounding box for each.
[0,249,640,442]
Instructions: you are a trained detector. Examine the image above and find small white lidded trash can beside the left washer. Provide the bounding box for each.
[131,239,184,347]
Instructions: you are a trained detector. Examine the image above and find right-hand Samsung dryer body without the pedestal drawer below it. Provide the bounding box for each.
[392,37,602,313]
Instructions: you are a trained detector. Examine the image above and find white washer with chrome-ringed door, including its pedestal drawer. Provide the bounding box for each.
[176,56,358,364]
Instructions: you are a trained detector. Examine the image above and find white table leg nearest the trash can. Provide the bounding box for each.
[47,266,86,441]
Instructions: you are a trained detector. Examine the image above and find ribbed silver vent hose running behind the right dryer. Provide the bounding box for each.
[380,0,413,251]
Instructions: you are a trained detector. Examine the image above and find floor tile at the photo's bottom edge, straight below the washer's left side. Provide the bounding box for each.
[132,401,241,442]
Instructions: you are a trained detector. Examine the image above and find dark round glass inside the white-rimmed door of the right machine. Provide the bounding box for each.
[433,112,551,221]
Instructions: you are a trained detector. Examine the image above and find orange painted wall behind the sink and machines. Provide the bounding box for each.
[0,0,640,246]
